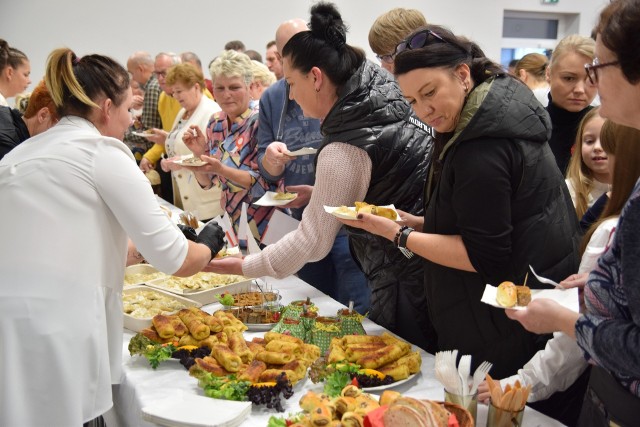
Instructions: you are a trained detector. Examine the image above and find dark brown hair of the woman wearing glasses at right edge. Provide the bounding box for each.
[594,0,640,84]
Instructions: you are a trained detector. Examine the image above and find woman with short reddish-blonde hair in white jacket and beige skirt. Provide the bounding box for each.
[160,63,223,220]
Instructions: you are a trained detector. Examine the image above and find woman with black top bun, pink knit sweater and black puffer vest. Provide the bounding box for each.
[212,3,436,352]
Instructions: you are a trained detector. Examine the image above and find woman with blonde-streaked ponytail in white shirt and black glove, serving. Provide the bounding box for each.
[0,49,223,427]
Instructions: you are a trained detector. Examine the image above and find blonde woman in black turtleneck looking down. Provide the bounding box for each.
[547,34,597,174]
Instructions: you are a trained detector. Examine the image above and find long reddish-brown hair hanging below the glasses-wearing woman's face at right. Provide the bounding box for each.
[581,119,640,253]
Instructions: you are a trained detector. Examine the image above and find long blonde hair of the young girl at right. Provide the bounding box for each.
[567,107,600,219]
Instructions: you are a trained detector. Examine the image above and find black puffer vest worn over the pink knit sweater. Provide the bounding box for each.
[316,61,434,349]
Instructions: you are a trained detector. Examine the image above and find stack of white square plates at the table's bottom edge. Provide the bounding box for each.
[142,390,251,427]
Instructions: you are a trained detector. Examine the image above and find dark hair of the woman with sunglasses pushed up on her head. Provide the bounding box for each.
[394,25,505,85]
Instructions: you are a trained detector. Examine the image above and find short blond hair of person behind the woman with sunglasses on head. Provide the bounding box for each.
[369,7,427,55]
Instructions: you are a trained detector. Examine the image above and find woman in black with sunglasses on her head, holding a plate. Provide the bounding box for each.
[344,25,579,386]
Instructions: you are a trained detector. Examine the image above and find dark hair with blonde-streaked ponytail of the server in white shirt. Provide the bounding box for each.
[45,48,129,118]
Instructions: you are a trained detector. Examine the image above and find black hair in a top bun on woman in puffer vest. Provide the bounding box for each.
[282,2,365,91]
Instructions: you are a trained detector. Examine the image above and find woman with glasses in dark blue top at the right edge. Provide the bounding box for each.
[507,0,640,426]
